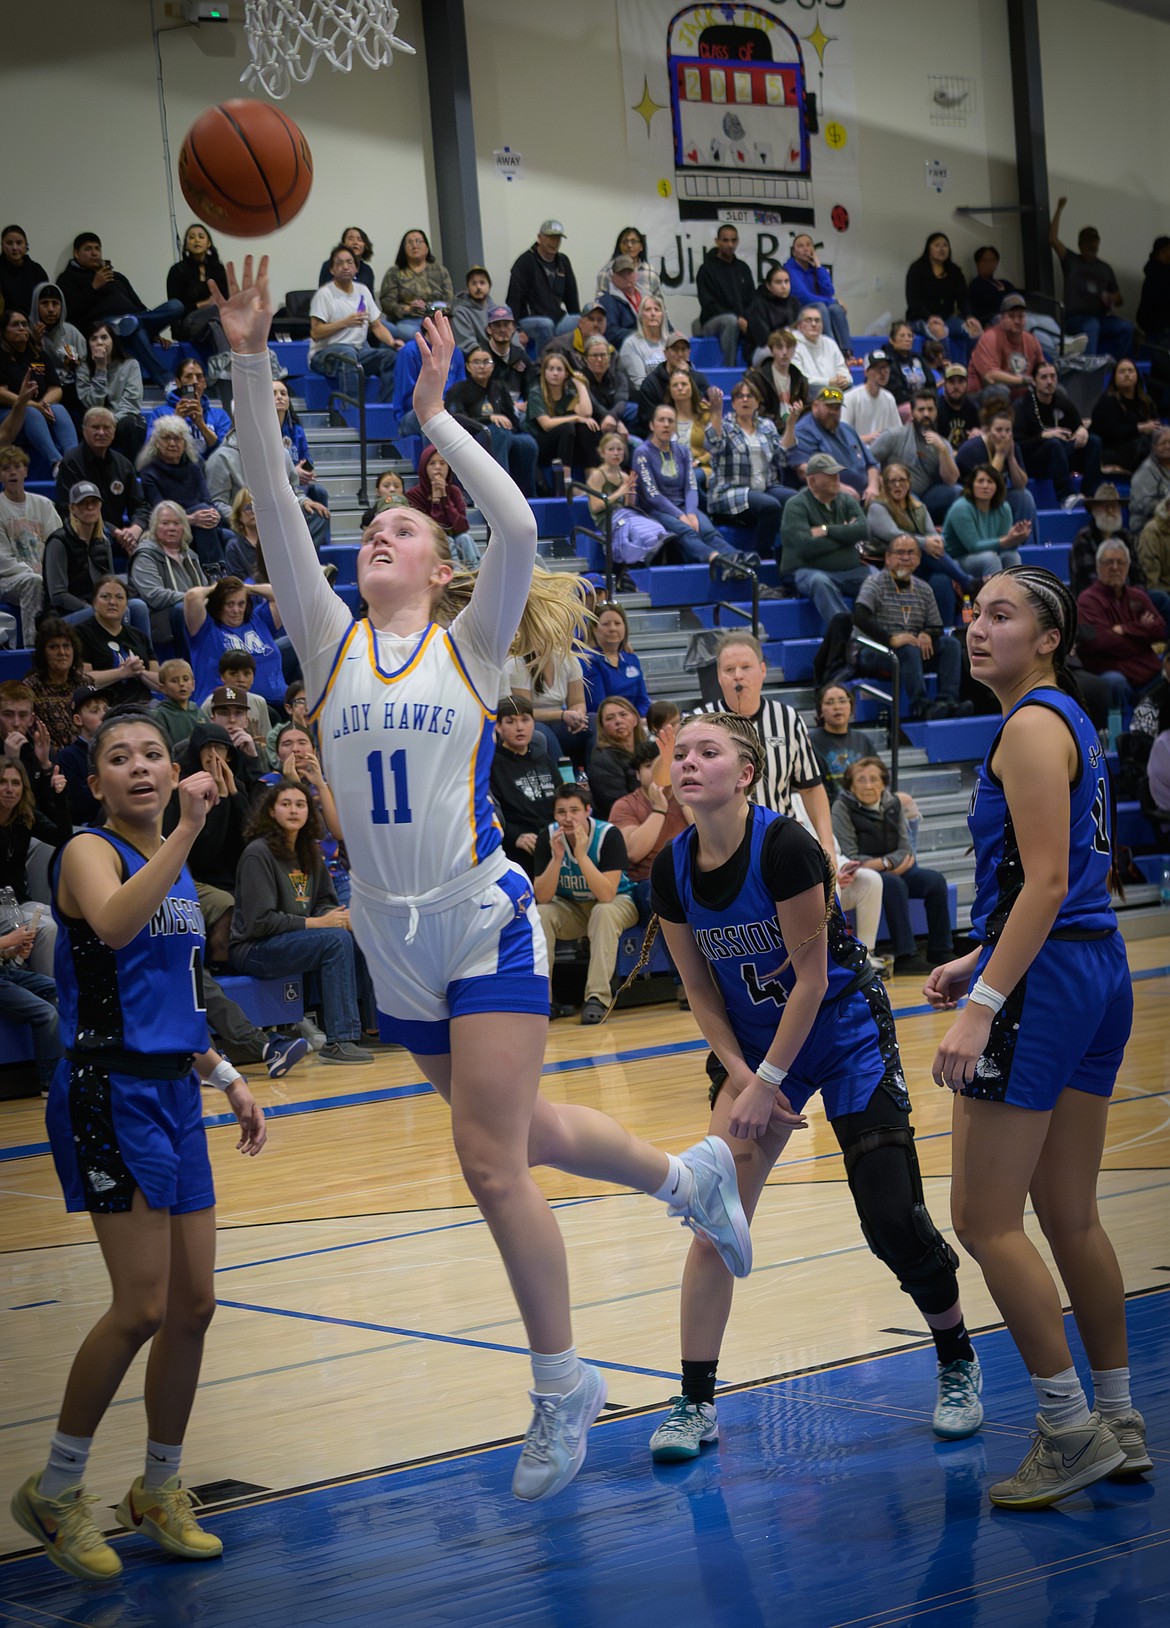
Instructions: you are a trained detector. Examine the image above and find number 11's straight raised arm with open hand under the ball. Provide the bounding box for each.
[208,254,350,663]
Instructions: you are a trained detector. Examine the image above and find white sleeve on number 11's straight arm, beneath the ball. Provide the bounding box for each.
[231,352,353,687]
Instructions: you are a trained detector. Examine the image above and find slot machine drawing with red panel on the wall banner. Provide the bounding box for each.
[667,5,815,226]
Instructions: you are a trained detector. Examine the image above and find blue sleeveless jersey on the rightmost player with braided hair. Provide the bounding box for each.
[967,687,1116,944]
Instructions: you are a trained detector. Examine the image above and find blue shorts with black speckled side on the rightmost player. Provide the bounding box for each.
[962,933,1134,1114]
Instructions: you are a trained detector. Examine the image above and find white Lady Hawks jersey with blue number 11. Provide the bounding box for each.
[311,622,503,899]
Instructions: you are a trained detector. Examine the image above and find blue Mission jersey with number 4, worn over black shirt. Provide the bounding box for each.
[670,807,872,1089]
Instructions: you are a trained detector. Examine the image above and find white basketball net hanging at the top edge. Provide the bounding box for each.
[241,0,415,101]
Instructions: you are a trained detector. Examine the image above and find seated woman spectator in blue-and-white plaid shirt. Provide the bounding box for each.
[706,379,807,573]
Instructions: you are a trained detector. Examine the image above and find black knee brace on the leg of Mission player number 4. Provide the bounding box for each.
[843,1125,958,1315]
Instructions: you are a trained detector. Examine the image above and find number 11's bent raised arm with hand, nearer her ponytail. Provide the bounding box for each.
[413,313,537,666]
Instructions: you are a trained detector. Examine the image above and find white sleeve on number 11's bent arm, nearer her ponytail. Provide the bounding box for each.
[426,410,537,667]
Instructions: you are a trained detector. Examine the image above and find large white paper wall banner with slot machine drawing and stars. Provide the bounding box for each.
[618,0,862,303]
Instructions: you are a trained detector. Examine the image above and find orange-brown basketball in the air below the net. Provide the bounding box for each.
[179,99,312,238]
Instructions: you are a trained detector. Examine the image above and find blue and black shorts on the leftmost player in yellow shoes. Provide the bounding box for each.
[46,1058,215,1214]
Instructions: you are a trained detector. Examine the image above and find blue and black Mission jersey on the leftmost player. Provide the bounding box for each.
[52,829,210,1058]
